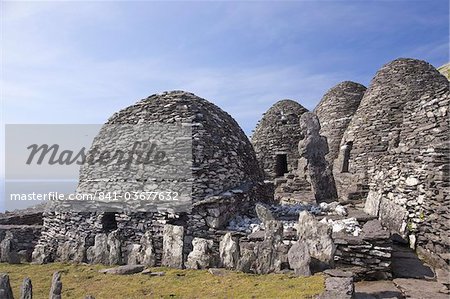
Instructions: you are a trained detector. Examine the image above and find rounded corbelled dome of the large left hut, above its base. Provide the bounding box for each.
[78,91,262,201]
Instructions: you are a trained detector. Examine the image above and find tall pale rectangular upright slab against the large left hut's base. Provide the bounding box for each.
[161,224,184,269]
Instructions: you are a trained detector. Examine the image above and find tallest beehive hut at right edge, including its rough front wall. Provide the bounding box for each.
[333,59,450,261]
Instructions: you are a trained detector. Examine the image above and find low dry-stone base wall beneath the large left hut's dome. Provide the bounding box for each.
[33,185,270,266]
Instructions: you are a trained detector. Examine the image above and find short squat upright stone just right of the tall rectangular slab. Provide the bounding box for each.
[185,238,214,269]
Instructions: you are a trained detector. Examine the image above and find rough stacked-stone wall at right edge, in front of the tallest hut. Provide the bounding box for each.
[365,61,450,267]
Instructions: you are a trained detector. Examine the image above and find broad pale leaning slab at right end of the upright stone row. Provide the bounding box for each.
[297,211,336,270]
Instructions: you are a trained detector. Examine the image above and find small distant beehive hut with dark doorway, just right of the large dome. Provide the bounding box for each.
[251,100,308,179]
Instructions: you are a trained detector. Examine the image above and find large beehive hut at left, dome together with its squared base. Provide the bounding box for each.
[33,91,262,265]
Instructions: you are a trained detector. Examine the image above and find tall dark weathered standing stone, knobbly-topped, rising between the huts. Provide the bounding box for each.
[298,112,337,203]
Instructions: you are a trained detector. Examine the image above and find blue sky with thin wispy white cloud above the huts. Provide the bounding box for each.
[0,0,449,209]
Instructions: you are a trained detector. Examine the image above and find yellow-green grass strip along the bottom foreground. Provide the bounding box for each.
[0,263,324,299]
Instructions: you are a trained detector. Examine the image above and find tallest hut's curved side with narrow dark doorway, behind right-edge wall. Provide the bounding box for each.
[333,59,448,199]
